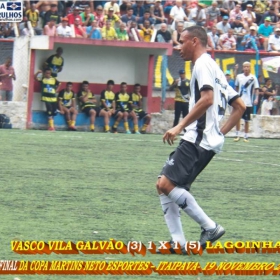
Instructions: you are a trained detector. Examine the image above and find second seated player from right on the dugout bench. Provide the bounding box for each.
[113,82,140,134]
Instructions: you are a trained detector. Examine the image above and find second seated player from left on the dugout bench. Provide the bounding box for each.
[78,81,109,132]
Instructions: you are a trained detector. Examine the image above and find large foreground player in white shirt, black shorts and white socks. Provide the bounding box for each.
[157,26,245,254]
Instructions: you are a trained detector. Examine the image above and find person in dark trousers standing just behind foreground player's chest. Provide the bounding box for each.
[170,70,190,127]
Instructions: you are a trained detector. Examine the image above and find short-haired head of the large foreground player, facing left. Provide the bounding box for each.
[180,26,207,61]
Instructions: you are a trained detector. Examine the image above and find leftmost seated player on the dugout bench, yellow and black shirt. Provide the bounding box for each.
[58,82,78,131]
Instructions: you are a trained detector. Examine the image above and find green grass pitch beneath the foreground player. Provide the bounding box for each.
[0,130,280,280]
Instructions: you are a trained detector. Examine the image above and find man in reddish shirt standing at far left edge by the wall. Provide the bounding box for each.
[0,58,16,101]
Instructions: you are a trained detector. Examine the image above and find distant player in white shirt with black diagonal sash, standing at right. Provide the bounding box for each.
[234,61,259,142]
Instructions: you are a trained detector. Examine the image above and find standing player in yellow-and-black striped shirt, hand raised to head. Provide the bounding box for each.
[35,68,60,131]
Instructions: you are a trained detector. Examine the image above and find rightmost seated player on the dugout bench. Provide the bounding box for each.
[130,84,151,134]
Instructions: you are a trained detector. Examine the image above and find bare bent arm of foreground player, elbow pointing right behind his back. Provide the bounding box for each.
[220,95,246,135]
